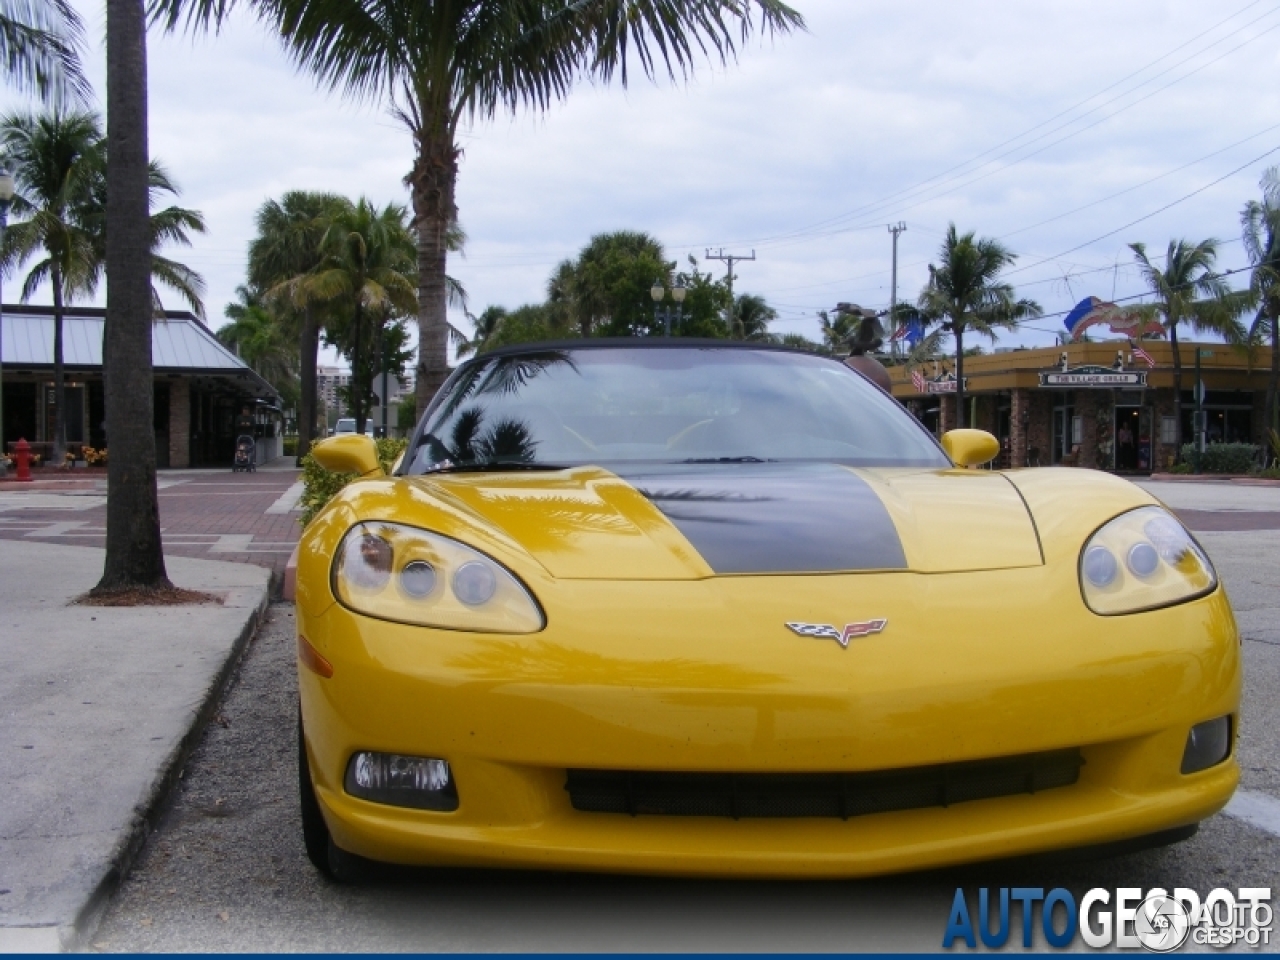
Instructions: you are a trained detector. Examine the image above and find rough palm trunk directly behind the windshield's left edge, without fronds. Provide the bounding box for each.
[410,122,458,417]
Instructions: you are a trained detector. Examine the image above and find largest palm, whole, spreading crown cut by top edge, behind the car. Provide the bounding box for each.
[157,0,804,412]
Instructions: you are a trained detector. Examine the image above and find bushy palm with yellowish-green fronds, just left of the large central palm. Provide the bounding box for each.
[285,198,417,433]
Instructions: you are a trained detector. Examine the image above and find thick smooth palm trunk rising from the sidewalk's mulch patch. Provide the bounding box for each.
[93,0,170,594]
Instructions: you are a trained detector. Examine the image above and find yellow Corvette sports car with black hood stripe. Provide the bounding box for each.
[297,338,1240,877]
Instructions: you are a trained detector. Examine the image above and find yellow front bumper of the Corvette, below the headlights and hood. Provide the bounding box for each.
[298,567,1240,877]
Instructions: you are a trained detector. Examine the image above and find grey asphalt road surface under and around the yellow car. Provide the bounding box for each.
[93,485,1280,952]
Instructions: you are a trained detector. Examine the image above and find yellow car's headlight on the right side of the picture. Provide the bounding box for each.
[1080,507,1217,616]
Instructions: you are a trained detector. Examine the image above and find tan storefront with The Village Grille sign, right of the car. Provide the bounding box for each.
[890,340,1271,474]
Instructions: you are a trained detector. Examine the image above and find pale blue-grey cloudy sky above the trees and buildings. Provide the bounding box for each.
[10,0,1280,360]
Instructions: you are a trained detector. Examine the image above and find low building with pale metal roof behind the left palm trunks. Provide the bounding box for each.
[0,305,283,467]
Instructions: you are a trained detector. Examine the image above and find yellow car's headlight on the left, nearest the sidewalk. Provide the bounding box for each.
[333,521,547,634]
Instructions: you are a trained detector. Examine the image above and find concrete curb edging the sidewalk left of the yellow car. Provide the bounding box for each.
[63,588,271,952]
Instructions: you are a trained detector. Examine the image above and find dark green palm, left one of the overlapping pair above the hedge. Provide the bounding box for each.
[248,189,351,462]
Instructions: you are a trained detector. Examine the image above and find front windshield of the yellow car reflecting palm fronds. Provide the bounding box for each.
[402,346,948,474]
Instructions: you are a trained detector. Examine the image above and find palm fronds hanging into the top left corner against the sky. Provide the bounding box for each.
[0,0,92,106]
